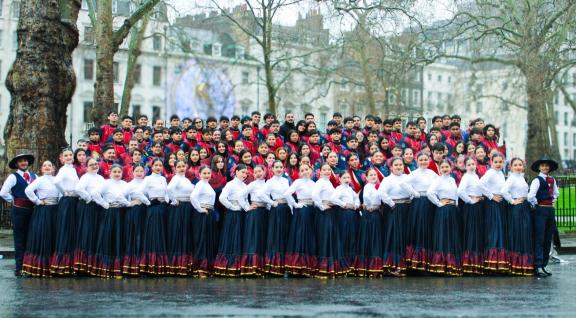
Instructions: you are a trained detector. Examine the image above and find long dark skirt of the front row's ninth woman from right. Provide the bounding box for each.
[315,208,350,278]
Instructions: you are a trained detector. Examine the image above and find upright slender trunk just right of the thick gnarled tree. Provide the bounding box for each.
[91,0,118,127]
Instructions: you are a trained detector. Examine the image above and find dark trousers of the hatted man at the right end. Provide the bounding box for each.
[534,206,556,268]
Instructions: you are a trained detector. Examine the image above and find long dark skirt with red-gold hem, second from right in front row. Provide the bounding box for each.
[484,200,510,273]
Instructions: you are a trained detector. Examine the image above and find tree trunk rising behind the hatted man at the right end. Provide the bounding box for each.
[524,68,559,176]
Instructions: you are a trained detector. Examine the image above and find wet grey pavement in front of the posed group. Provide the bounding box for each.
[0,256,576,317]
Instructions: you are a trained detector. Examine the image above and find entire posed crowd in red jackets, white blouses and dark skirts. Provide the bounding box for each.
[0,112,558,278]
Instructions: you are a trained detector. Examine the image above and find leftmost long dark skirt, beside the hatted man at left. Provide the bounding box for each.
[22,204,58,277]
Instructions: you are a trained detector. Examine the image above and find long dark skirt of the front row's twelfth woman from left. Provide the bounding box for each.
[285,206,317,276]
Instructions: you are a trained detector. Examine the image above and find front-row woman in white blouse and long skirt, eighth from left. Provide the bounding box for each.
[189,166,218,277]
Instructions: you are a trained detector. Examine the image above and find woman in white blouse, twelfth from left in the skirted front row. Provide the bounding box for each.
[284,165,318,276]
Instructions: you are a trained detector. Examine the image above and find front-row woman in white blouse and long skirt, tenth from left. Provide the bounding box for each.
[240,165,278,276]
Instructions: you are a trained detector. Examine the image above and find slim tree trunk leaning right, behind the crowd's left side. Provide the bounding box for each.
[120,14,150,120]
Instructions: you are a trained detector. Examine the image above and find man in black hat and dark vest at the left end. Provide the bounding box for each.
[0,154,36,276]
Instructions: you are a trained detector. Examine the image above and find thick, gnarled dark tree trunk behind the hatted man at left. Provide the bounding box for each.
[2,0,81,171]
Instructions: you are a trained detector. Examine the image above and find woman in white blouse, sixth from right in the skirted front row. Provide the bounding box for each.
[378,157,420,276]
